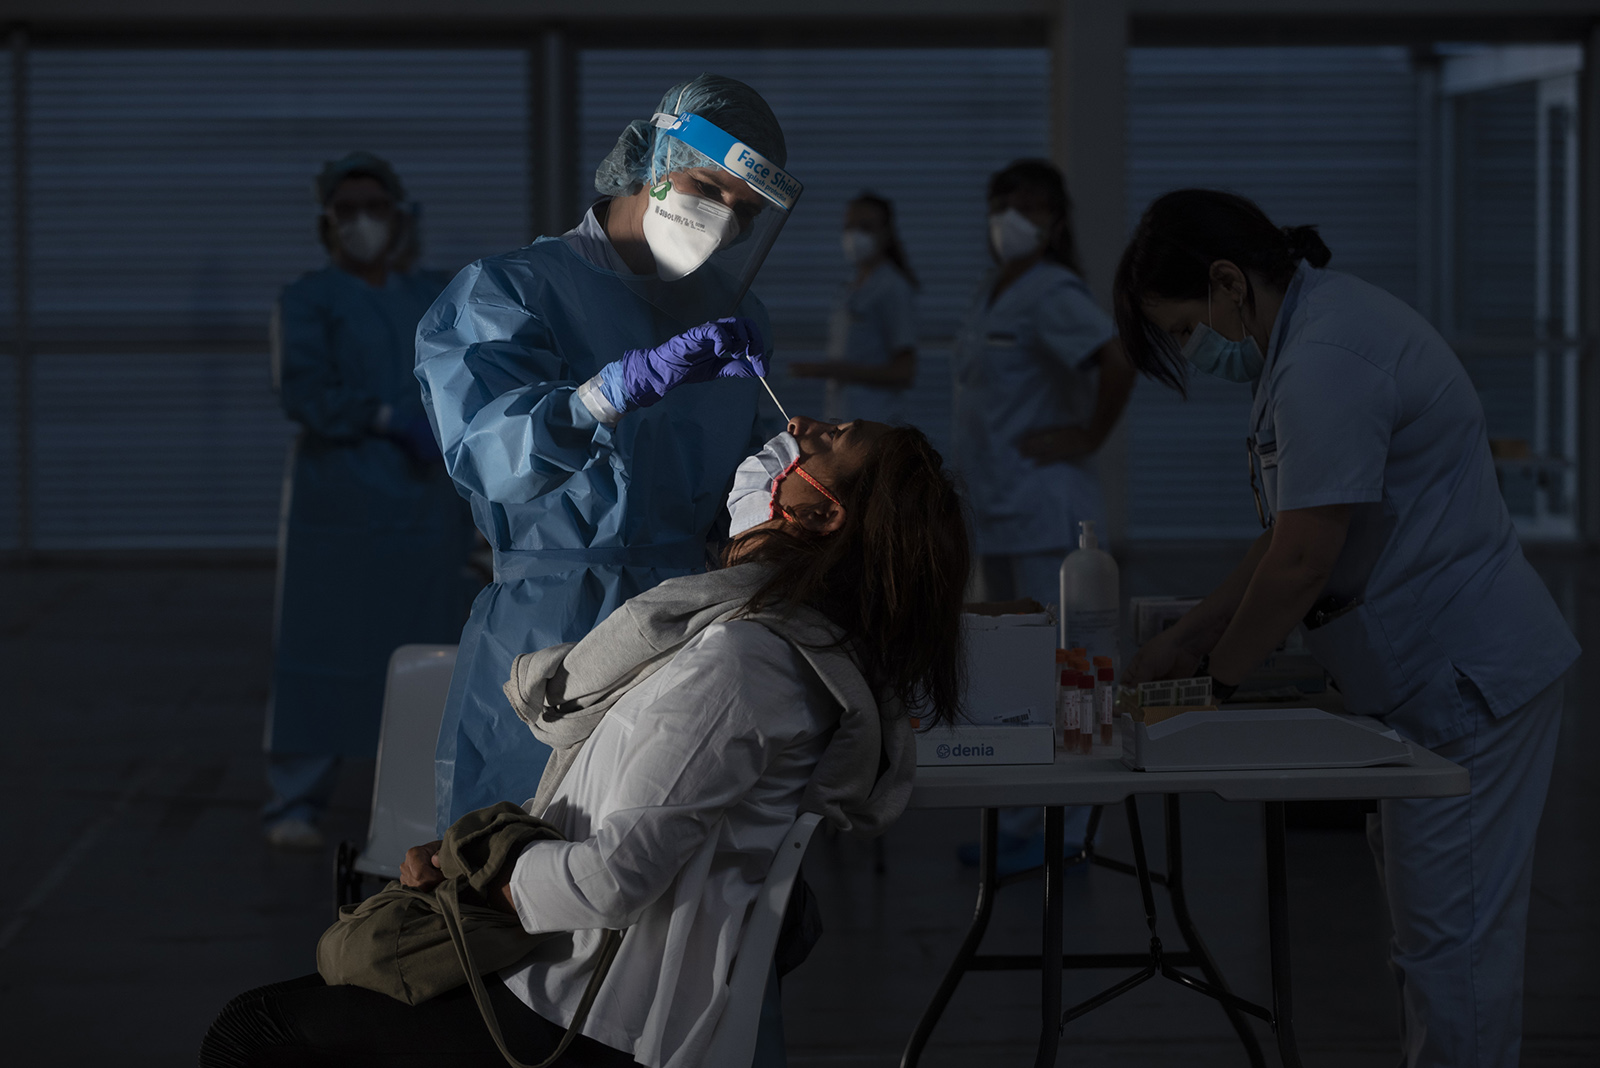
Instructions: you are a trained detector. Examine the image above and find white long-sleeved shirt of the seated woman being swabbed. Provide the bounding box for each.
[501,620,838,1068]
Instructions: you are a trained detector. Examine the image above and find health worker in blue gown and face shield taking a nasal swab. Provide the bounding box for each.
[416,75,800,833]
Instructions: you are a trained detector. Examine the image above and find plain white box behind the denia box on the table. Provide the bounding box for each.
[962,612,1058,725]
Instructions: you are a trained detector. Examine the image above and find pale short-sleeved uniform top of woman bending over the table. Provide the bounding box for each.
[1251,264,1578,745]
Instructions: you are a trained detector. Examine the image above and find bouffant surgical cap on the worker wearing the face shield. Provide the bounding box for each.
[595,74,789,197]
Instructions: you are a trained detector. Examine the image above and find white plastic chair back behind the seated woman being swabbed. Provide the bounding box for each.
[699,812,822,1068]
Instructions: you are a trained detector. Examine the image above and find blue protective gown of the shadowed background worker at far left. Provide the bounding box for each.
[267,267,472,756]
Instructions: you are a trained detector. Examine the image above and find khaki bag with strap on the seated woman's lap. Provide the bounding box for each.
[317,801,622,1068]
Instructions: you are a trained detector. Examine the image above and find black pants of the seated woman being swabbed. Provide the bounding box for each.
[200,975,637,1068]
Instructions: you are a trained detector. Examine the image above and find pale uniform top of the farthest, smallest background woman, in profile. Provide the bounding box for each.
[827,261,917,422]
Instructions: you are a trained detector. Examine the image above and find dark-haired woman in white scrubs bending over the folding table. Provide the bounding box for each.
[1115,190,1578,1068]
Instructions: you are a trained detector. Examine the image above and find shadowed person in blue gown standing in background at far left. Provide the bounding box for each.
[266,152,472,849]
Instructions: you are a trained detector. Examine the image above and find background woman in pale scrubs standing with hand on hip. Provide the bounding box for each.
[952,160,1134,875]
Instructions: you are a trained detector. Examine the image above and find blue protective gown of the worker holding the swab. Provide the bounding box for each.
[416,238,770,833]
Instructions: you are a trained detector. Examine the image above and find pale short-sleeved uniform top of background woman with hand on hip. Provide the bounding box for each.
[952,261,1117,555]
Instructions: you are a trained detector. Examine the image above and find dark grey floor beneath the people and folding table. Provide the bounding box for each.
[0,550,1600,1068]
